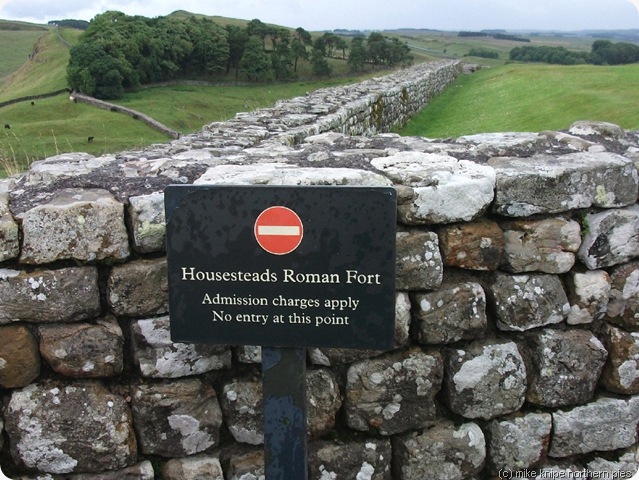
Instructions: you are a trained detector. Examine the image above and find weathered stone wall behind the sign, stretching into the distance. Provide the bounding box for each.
[0,62,639,480]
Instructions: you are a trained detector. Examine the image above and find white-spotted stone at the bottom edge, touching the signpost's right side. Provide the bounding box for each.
[308,438,393,480]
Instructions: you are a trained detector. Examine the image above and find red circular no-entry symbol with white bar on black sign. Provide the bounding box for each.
[254,206,304,255]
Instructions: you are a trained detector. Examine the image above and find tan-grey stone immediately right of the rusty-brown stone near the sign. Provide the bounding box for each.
[501,218,581,273]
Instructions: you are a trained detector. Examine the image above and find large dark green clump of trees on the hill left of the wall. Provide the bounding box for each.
[67,11,412,99]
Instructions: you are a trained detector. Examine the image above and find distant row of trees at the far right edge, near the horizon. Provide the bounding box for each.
[509,40,639,65]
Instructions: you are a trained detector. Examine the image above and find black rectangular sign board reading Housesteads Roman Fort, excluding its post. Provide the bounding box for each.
[164,185,397,349]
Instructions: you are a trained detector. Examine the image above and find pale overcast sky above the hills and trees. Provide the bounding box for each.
[0,0,639,31]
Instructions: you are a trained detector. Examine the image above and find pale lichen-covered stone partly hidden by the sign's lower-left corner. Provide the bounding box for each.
[131,317,231,378]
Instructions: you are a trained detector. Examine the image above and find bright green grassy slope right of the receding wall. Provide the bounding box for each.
[401,64,639,138]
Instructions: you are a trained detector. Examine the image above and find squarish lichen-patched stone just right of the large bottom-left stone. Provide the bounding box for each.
[131,378,223,457]
